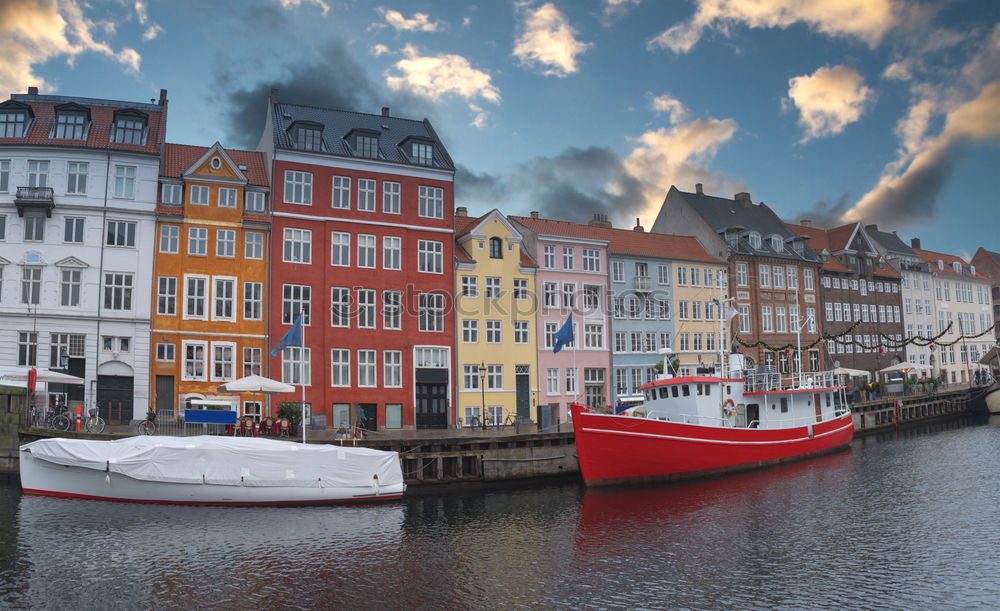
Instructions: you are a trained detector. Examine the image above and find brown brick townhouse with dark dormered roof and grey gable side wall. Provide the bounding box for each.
[653,184,830,373]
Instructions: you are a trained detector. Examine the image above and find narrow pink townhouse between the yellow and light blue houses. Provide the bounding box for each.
[510,213,611,427]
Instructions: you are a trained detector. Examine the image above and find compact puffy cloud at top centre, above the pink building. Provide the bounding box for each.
[514,2,590,77]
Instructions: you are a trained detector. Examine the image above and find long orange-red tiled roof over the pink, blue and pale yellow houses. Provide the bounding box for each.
[510,216,725,264]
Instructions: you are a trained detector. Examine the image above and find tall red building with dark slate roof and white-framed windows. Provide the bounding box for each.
[258,91,455,429]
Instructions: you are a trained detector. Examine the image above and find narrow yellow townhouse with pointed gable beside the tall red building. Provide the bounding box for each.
[455,207,538,426]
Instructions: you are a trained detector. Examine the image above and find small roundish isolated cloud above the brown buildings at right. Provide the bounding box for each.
[783,66,874,142]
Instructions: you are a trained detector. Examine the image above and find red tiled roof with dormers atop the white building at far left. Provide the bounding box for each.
[0,94,166,153]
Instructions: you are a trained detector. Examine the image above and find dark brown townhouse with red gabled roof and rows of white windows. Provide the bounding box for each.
[787,220,906,372]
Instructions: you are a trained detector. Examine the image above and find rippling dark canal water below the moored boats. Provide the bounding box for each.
[0,419,1000,609]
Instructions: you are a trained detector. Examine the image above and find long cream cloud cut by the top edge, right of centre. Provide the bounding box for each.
[648,0,900,53]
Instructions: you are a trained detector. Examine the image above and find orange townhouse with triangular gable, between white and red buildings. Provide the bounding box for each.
[150,142,271,417]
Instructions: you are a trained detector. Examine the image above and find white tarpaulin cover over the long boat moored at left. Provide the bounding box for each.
[21,435,403,488]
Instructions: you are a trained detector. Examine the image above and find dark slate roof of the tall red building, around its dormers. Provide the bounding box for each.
[272,102,455,170]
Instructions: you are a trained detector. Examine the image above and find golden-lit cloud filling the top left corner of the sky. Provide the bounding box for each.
[0,0,142,91]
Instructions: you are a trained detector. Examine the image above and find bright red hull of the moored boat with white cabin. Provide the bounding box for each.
[572,406,854,486]
